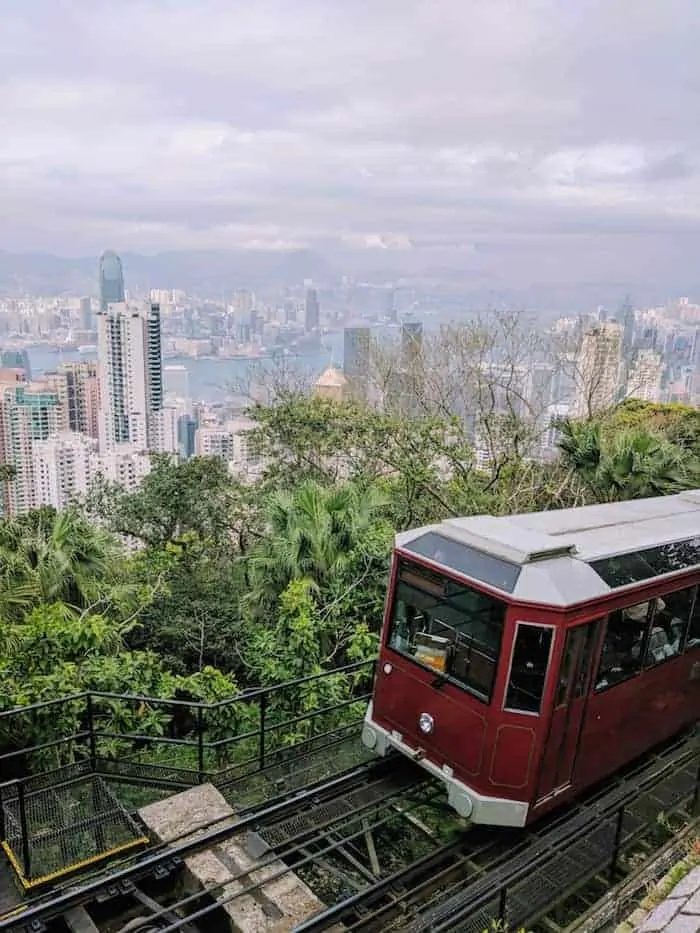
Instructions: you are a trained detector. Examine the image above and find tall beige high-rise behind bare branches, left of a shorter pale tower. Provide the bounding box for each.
[572,321,623,418]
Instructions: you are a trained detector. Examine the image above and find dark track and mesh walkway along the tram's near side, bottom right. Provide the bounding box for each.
[297,736,700,933]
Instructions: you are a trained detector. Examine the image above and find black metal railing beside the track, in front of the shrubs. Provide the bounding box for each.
[0,661,374,886]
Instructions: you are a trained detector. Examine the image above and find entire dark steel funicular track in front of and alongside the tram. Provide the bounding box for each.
[0,736,700,933]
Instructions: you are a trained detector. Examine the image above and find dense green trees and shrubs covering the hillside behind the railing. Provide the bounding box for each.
[0,386,700,780]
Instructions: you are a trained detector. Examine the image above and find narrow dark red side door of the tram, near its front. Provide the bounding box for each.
[537,619,600,801]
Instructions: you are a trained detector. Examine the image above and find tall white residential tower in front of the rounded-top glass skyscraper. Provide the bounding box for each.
[97,302,163,452]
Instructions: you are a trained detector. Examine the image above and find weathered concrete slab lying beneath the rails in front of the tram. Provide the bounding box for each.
[139,784,340,933]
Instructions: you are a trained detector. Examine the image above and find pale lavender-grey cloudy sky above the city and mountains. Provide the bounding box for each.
[0,0,700,281]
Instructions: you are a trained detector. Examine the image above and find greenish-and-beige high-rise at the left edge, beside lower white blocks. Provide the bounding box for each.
[0,383,61,515]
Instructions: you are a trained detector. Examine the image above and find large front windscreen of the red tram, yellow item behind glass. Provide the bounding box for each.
[389,560,506,702]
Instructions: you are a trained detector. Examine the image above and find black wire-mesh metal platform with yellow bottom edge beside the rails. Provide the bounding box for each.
[2,776,149,889]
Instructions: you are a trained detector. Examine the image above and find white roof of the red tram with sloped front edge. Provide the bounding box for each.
[396,489,700,607]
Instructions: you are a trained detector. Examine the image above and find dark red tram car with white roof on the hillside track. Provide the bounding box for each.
[362,490,700,826]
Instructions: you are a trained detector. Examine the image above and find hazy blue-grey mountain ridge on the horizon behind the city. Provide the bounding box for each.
[0,242,688,313]
